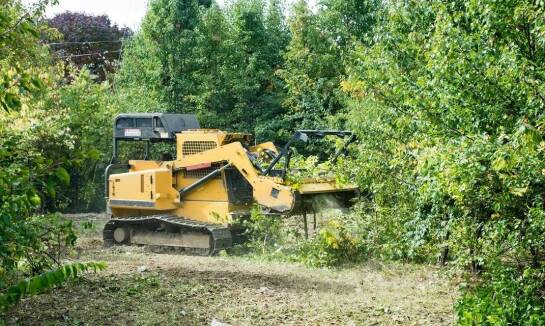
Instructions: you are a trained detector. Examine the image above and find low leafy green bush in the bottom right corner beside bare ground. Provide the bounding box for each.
[456,267,545,325]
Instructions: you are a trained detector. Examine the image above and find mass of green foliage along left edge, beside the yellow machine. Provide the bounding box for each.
[0,1,113,309]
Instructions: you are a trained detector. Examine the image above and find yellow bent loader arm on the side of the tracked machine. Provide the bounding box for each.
[173,142,295,213]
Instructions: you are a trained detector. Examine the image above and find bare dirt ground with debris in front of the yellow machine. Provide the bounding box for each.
[6,215,457,326]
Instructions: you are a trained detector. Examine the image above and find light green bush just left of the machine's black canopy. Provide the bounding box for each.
[48,68,117,211]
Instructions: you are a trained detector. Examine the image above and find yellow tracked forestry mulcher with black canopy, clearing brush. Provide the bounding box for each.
[103,113,358,255]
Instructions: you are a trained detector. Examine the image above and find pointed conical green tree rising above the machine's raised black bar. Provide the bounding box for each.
[279,0,344,129]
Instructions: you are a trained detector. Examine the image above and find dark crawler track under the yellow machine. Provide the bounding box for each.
[102,215,233,256]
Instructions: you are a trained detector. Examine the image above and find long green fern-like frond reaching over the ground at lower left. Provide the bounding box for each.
[0,262,106,311]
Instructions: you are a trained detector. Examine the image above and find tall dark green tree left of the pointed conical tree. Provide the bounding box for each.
[216,1,286,138]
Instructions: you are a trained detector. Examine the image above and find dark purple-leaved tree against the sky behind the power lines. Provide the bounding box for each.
[47,11,132,81]
